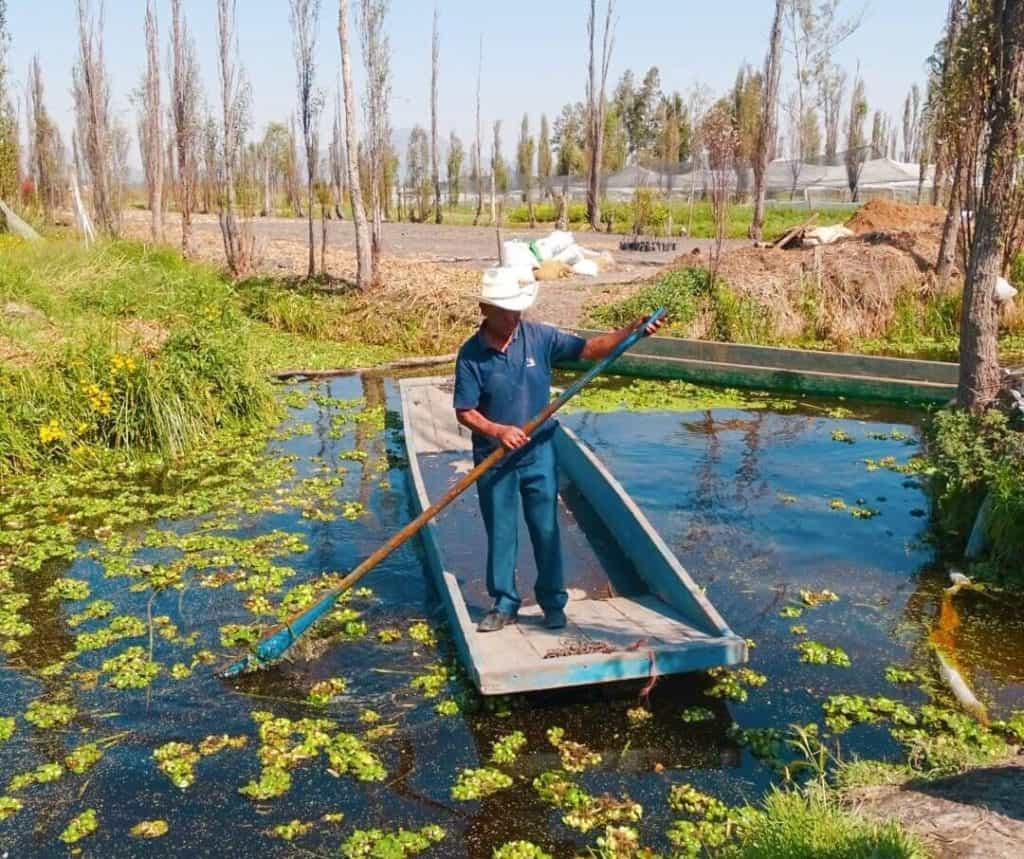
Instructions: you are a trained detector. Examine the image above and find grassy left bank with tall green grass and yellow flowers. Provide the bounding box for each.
[0,237,462,477]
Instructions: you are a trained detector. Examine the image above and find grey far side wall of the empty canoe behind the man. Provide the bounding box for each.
[575,329,959,385]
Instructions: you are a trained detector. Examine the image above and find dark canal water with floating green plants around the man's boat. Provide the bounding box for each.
[0,377,1024,857]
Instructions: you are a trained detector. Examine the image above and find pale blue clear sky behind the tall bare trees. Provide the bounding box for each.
[8,0,947,169]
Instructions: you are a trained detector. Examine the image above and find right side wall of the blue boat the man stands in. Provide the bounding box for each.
[555,426,732,636]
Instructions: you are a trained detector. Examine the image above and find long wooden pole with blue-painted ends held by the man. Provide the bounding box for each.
[220,307,665,677]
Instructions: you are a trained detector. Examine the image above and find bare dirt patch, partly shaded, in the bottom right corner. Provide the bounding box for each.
[849,756,1024,859]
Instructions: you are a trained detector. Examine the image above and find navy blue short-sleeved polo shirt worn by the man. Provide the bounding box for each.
[454,320,587,466]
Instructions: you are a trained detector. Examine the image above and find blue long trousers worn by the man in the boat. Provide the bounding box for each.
[476,440,568,614]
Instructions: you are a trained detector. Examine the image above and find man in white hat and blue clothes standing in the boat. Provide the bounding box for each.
[454,268,662,633]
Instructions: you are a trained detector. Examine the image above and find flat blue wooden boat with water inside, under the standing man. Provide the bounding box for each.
[400,377,746,695]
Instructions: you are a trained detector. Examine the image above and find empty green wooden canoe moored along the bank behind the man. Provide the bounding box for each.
[562,330,959,403]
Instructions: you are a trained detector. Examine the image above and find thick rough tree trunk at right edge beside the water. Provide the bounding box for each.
[956,0,1024,413]
